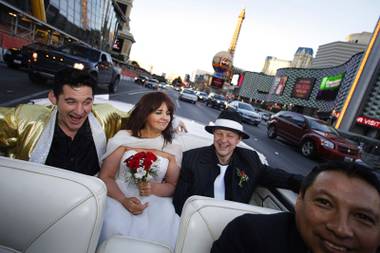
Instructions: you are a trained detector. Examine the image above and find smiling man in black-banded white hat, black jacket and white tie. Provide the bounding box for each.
[173,111,303,215]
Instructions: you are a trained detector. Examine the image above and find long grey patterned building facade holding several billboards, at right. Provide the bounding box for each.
[237,53,363,115]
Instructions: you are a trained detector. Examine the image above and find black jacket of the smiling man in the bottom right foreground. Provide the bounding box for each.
[211,212,309,253]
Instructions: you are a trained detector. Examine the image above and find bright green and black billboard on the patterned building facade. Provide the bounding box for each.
[317,73,344,101]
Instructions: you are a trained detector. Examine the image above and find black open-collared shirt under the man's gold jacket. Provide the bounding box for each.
[45,119,100,176]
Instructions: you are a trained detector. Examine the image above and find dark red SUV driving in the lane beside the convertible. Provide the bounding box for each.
[267,111,360,161]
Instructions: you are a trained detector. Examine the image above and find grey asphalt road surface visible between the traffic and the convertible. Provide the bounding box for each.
[0,65,317,175]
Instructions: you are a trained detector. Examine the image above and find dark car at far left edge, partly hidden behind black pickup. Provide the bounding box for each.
[3,42,49,68]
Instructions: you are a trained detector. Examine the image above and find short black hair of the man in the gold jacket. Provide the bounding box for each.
[53,68,95,98]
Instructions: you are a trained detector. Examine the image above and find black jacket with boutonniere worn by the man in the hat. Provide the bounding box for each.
[173,145,302,215]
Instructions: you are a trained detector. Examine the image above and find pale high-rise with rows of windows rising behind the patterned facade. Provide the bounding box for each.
[311,32,371,68]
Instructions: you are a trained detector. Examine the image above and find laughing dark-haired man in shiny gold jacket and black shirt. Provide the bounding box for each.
[0,68,127,175]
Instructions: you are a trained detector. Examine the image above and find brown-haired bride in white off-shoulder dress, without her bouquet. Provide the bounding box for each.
[99,92,182,249]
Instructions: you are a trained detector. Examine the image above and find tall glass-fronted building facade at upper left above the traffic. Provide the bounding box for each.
[0,0,134,60]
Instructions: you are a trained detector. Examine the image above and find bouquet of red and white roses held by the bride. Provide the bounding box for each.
[124,151,158,184]
